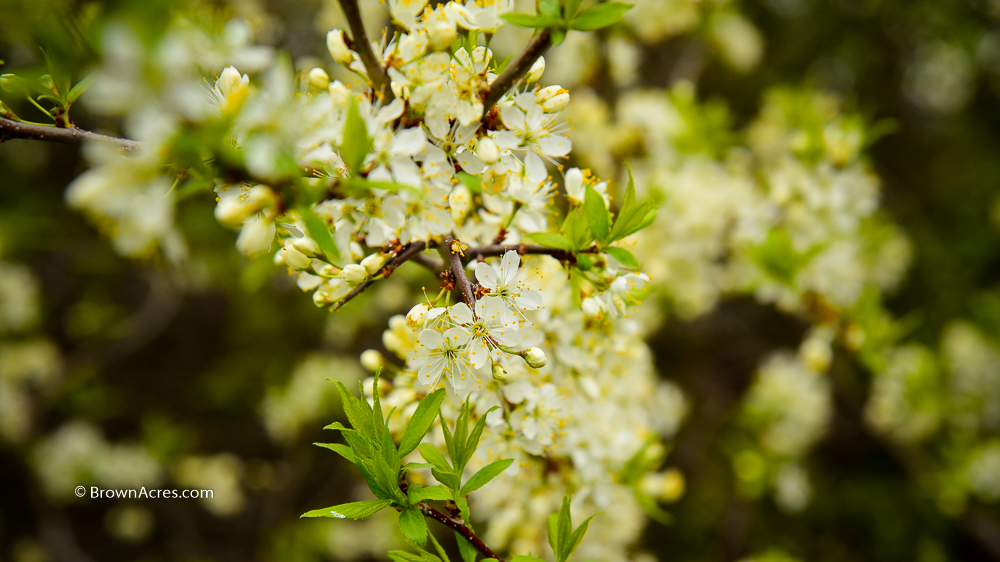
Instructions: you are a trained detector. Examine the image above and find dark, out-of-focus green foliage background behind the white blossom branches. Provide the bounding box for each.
[0,0,1000,562]
